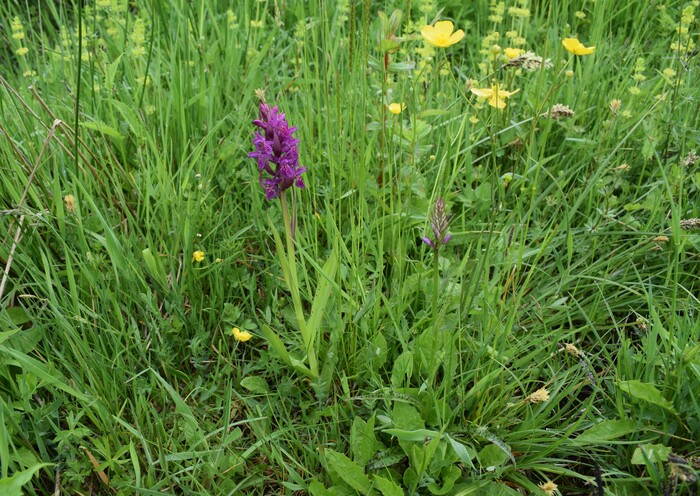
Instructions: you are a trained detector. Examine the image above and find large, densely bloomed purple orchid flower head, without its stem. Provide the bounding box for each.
[248,102,306,200]
